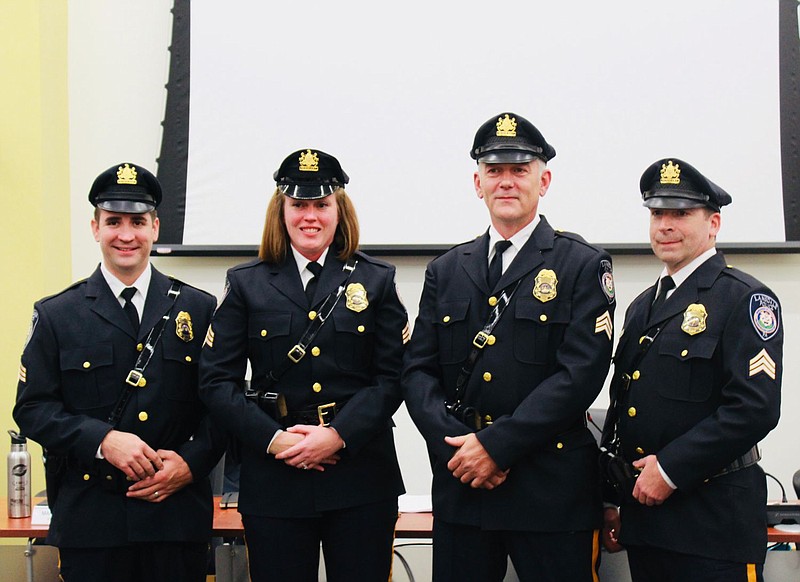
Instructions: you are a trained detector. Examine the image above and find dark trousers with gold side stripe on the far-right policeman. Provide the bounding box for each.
[627,546,764,582]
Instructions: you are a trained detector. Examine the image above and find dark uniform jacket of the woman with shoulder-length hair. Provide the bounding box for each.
[200,247,408,518]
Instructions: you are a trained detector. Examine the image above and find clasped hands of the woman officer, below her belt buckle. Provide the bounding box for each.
[267,424,344,471]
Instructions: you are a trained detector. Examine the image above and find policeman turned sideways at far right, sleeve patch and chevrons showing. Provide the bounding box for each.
[604,158,783,582]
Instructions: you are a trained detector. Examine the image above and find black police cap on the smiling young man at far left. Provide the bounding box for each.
[89,162,161,214]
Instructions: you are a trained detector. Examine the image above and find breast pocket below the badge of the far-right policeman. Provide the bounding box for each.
[658,332,719,402]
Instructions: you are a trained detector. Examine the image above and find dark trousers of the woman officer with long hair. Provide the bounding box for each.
[242,499,397,582]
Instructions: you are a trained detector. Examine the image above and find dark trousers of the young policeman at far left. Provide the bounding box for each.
[58,542,208,582]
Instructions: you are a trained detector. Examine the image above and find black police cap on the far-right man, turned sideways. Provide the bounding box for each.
[639,158,731,212]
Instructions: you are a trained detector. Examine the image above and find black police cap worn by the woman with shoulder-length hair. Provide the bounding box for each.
[272,149,350,200]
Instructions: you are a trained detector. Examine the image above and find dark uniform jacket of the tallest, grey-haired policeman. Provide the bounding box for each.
[402,217,615,531]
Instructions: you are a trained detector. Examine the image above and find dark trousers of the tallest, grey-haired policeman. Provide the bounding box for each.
[433,519,600,582]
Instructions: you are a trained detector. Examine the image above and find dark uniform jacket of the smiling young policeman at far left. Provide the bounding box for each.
[14,267,225,547]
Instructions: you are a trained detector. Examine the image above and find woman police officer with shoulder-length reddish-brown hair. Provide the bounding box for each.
[200,149,408,582]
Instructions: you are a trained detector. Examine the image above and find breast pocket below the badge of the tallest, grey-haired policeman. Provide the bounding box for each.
[514,297,572,364]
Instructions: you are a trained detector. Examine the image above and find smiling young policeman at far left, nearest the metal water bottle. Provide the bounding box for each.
[14,163,225,582]
